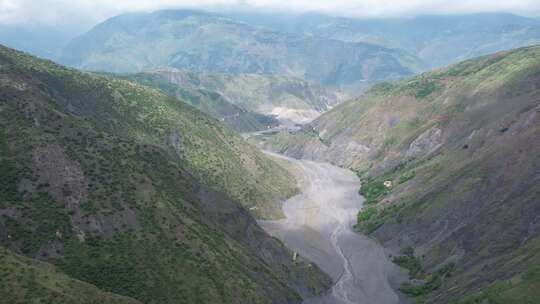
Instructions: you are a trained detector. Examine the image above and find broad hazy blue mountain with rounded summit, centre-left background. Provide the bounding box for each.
[60,10,422,92]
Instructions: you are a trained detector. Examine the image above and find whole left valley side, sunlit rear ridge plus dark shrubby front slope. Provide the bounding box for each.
[0,47,328,303]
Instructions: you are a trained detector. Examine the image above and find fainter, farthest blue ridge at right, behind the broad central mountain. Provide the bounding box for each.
[229,12,540,67]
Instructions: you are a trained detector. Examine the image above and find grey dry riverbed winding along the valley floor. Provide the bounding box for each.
[260,154,407,304]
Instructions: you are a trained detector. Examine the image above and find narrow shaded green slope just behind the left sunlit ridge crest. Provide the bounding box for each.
[122,73,279,132]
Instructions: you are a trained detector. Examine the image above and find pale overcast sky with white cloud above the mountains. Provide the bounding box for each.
[0,0,540,26]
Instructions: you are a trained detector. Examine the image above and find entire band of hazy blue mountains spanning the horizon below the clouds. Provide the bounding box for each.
[4,10,540,94]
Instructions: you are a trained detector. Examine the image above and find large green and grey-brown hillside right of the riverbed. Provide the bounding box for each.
[269,47,540,303]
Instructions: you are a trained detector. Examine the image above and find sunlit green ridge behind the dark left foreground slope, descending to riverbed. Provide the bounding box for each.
[2,44,296,218]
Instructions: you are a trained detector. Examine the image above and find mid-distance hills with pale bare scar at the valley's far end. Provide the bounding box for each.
[127,69,348,125]
